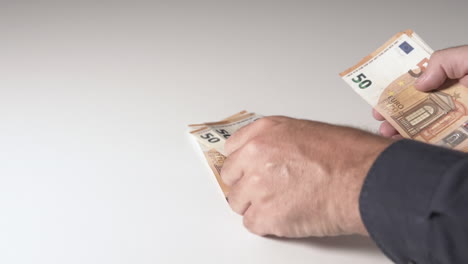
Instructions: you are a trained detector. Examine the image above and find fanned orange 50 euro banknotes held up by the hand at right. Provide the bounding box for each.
[340,30,468,152]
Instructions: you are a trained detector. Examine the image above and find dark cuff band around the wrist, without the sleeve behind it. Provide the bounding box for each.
[359,139,466,263]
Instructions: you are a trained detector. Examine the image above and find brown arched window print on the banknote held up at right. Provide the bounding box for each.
[393,92,456,137]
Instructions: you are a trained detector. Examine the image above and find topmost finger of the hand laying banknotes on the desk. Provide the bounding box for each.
[224,117,279,156]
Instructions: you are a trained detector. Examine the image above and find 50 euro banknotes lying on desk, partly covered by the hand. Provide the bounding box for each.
[189,111,262,196]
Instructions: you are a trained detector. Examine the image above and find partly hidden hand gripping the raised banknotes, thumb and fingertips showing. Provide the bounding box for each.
[372,45,468,138]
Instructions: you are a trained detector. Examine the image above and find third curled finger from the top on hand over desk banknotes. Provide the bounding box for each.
[227,176,253,215]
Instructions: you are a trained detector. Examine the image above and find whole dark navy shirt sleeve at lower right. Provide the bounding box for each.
[359,140,468,264]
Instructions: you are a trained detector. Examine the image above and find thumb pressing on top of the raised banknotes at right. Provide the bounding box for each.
[416,46,468,92]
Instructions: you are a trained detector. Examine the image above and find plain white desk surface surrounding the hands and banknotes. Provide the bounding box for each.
[0,0,468,264]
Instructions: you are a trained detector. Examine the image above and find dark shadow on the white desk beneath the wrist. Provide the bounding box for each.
[269,235,382,255]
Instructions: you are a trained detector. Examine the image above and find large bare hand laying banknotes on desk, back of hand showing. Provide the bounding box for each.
[221,116,392,237]
